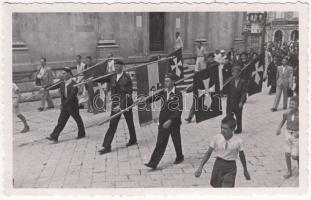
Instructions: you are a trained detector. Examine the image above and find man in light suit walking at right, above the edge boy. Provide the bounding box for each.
[271,57,293,112]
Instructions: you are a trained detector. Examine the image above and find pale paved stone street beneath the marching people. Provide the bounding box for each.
[13,83,299,188]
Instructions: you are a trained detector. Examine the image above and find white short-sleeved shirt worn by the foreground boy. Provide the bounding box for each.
[210,133,243,160]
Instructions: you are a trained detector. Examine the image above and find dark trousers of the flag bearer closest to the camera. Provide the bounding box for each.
[149,125,183,167]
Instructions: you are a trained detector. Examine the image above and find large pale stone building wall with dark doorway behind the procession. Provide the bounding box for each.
[13,12,245,72]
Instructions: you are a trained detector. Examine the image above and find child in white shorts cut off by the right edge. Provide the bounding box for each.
[276,96,299,178]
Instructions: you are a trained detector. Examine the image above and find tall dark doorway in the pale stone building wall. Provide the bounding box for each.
[149,12,164,51]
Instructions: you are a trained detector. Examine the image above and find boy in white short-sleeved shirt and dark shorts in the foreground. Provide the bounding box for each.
[194,117,250,187]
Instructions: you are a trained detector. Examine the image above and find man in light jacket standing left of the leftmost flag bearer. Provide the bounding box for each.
[36,57,54,111]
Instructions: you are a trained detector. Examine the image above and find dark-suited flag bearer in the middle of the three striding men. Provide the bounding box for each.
[98,60,137,154]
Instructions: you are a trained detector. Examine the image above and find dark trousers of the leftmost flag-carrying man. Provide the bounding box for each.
[51,108,85,139]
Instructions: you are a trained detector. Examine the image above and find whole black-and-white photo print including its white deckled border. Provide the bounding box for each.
[4,0,308,196]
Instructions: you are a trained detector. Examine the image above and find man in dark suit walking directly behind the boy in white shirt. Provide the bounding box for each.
[227,66,247,134]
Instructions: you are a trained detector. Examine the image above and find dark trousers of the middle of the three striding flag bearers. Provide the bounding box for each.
[102,109,137,148]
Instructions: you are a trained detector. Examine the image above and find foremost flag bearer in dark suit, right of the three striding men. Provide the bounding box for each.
[145,74,184,169]
